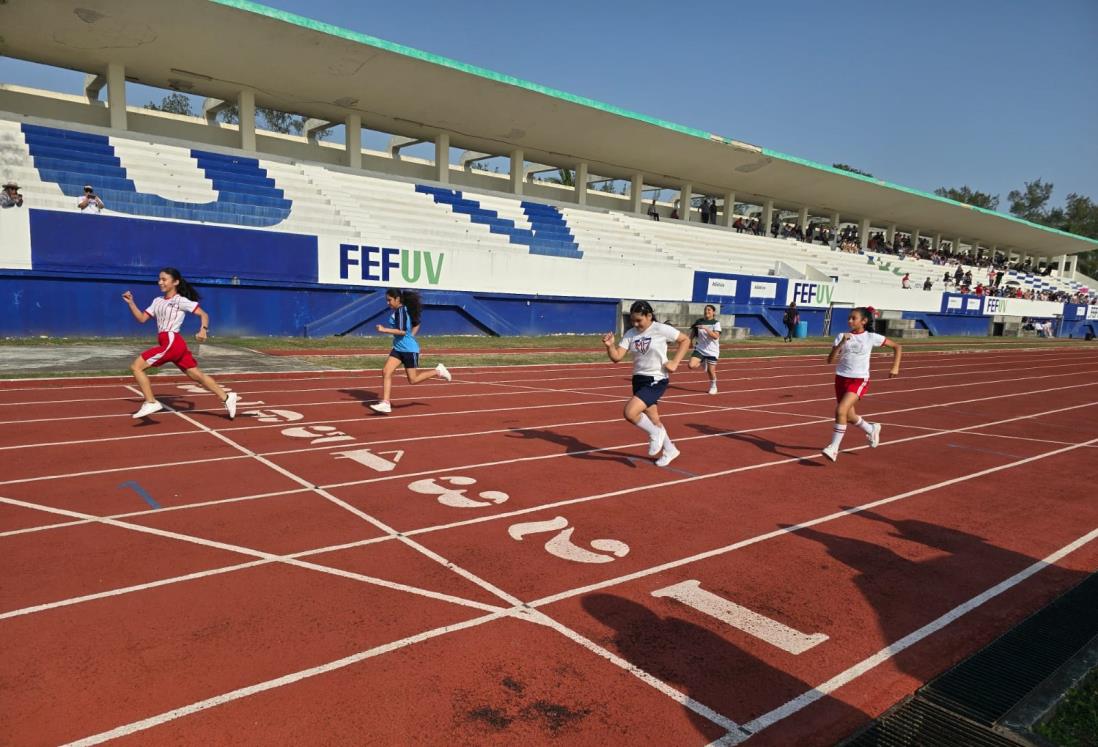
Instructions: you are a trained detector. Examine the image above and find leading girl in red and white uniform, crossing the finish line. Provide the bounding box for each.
[122,267,237,420]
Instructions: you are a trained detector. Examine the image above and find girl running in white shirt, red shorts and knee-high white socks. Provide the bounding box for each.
[824,306,903,461]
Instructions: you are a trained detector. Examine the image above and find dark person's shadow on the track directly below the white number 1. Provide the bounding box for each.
[582,593,865,744]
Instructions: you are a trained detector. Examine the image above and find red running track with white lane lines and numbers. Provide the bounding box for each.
[0,346,1098,745]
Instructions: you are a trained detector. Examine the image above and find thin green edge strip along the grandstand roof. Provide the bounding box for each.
[209,0,1098,246]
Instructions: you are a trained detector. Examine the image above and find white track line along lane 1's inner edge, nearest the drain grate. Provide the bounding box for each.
[717,528,1098,745]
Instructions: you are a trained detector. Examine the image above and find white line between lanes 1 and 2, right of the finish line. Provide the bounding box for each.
[528,432,1098,607]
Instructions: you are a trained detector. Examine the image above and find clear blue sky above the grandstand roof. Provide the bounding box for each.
[0,0,1098,210]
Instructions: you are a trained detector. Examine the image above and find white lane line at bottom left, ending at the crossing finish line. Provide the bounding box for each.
[68,612,509,747]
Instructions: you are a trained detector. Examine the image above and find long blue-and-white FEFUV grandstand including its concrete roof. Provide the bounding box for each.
[0,0,1098,336]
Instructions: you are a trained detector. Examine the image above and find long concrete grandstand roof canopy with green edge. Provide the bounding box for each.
[0,0,1098,256]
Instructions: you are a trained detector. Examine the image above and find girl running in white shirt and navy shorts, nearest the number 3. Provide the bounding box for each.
[603,301,690,467]
